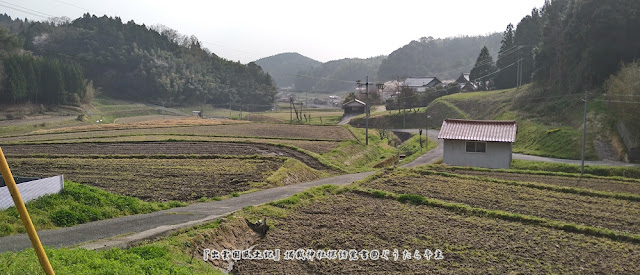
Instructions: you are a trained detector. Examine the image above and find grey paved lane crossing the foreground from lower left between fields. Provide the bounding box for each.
[0,172,373,252]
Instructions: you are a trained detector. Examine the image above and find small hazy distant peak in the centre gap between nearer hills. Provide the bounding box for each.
[255,53,322,88]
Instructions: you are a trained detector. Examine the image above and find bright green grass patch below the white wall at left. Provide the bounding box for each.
[0,181,185,236]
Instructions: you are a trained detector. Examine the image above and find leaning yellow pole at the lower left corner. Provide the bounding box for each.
[0,148,55,275]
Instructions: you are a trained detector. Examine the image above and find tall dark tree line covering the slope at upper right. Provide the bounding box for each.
[470,0,640,94]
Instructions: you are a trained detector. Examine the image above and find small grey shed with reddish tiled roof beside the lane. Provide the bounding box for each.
[438,119,518,168]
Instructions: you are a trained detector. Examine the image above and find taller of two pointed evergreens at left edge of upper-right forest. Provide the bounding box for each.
[494,24,518,89]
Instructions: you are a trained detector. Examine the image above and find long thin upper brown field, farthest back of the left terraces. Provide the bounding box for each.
[0,123,354,144]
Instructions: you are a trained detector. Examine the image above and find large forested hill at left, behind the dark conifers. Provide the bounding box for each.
[0,13,276,109]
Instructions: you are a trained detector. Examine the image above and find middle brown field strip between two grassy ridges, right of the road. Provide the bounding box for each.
[362,170,640,233]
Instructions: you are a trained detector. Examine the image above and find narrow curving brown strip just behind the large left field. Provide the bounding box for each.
[2,142,328,170]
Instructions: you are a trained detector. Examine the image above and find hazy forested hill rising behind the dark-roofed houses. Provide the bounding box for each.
[378,33,502,81]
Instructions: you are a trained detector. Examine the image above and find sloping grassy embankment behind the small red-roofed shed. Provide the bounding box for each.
[351,85,612,160]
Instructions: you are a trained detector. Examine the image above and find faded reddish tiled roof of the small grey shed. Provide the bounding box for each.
[438,119,518,142]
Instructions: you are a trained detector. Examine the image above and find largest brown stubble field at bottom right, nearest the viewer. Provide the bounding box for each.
[232,192,640,274]
